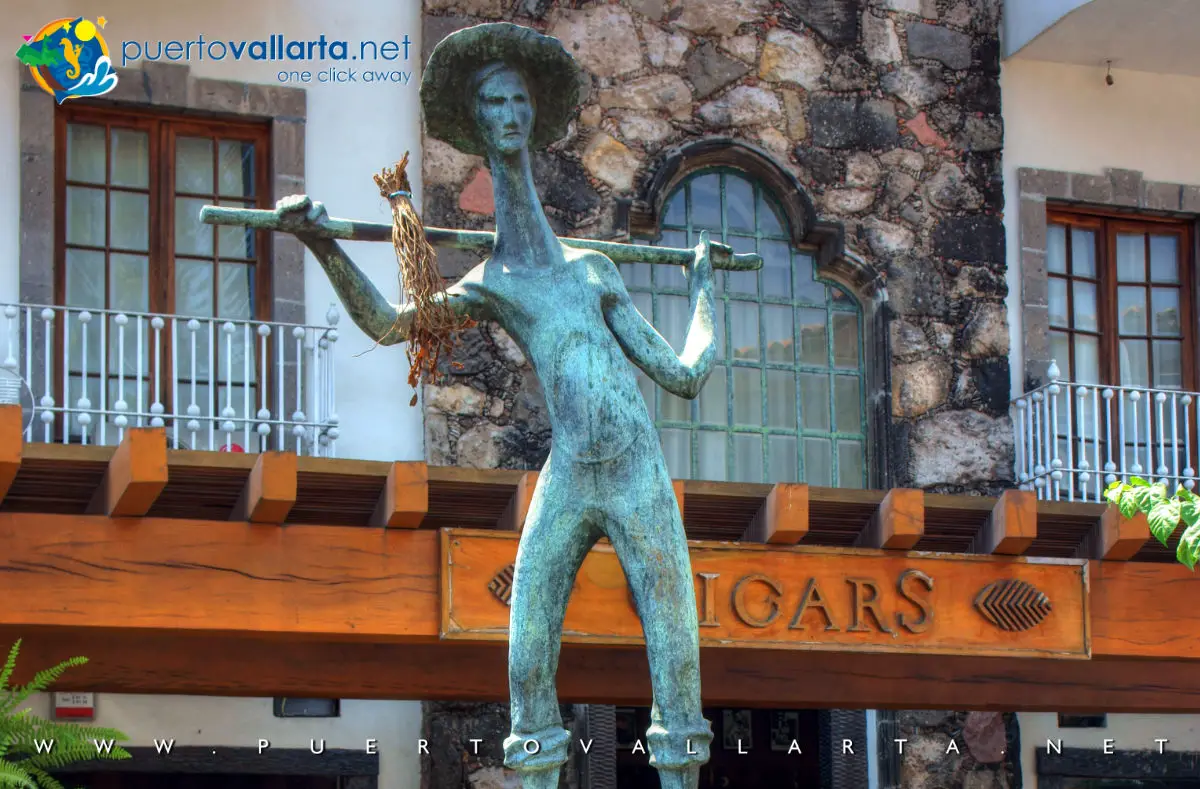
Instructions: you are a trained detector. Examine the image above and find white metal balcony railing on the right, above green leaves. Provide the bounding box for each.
[1012,362,1200,501]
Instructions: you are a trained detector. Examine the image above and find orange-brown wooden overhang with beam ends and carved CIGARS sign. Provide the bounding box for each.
[0,408,1200,712]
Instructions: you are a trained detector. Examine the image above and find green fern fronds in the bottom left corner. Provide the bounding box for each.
[0,640,131,789]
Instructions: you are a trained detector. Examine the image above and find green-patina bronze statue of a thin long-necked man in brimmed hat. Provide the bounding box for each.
[225,24,716,789]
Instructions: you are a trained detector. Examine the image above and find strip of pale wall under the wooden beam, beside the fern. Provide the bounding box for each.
[28,693,421,789]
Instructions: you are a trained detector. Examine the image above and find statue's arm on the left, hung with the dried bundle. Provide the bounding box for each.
[276,195,482,345]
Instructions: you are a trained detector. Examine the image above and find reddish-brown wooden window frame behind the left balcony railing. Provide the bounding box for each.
[53,103,274,426]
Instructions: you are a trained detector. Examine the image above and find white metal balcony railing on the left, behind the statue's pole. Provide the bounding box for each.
[0,305,338,456]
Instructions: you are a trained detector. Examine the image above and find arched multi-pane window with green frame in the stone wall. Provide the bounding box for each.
[622,168,868,488]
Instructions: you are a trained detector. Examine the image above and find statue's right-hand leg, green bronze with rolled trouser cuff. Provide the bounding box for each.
[606,447,713,789]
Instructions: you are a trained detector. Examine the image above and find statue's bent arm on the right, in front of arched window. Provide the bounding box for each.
[605,233,716,399]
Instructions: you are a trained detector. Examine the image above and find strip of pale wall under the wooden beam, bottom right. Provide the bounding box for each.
[1016,712,1200,789]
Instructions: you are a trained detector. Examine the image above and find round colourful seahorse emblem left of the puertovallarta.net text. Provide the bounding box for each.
[17,17,116,104]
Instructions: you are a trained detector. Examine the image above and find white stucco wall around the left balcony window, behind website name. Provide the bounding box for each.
[0,0,424,460]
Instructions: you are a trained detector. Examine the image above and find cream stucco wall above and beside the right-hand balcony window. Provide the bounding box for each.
[1000,59,1200,393]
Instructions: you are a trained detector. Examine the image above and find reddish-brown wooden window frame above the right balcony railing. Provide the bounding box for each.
[1046,206,1200,392]
